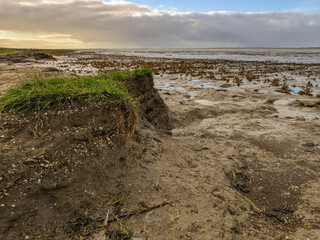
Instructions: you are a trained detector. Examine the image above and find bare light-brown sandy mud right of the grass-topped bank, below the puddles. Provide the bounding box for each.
[94,84,320,239]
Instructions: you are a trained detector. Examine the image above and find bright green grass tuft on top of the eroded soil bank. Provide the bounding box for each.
[0,69,151,113]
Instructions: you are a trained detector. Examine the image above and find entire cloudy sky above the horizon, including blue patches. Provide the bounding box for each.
[0,0,320,48]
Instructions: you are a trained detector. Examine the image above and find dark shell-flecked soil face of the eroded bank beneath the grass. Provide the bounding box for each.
[0,70,170,239]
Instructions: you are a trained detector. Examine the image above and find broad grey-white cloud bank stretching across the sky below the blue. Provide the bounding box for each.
[0,0,320,48]
